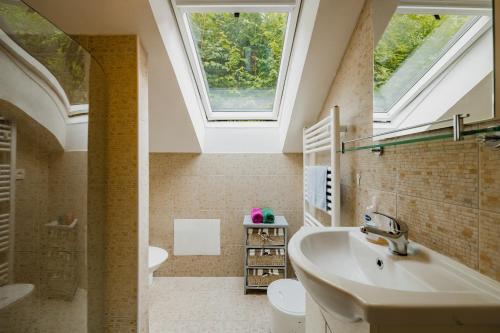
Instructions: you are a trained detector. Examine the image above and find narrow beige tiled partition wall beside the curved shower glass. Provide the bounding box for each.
[84,36,147,333]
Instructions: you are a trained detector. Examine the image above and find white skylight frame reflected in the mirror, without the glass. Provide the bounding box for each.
[373,1,493,124]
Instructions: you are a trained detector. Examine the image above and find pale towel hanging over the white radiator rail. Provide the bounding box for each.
[304,165,328,210]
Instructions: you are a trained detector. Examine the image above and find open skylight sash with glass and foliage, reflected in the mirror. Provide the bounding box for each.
[374,13,491,121]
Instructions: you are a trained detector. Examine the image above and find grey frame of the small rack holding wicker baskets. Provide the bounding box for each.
[243,215,288,294]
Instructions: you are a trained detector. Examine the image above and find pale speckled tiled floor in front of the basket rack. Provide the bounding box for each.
[149,277,271,333]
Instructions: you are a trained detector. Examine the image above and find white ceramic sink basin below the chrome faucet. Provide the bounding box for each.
[289,227,500,325]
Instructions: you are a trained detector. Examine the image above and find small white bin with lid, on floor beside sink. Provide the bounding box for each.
[267,279,306,333]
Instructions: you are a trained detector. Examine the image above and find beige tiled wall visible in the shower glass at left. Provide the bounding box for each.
[10,110,87,291]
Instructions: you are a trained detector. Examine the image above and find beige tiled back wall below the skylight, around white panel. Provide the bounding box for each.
[150,153,303,276]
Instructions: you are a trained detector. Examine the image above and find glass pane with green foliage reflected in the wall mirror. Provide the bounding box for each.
[373,14,478,112]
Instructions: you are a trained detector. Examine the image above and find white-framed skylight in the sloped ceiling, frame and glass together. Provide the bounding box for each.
[176,1,297,121]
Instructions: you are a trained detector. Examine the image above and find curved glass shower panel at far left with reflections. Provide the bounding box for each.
[0,0,104,333]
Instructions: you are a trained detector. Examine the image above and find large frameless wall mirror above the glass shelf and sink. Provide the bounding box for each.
[373,0,494,138]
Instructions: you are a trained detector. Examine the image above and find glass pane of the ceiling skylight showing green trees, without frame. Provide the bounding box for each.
[188,12,288,111]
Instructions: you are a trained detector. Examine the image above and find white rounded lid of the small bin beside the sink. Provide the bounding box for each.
[267,279,306,316]
